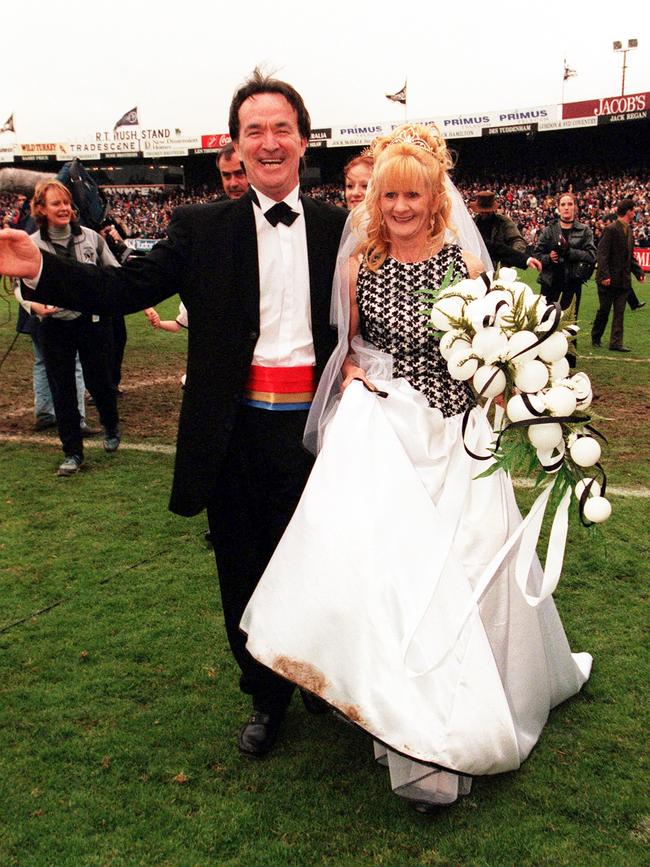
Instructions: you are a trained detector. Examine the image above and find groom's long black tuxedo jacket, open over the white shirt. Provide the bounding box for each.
[33,195,346,515]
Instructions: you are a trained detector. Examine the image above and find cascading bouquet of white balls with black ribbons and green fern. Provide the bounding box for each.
[428,268,611,526]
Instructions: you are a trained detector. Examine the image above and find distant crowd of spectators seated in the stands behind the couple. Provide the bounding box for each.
[0,168,650,247]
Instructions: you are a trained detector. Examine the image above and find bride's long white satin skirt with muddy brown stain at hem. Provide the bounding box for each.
[241,380,591,804]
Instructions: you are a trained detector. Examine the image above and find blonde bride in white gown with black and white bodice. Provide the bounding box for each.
[241,125,591,809]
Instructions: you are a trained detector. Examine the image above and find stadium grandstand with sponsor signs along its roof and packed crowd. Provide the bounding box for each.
[0,92,650,267]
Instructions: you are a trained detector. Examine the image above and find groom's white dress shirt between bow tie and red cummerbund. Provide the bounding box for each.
[253,186,316,367]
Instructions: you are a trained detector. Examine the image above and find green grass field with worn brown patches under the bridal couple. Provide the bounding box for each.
[0,274,650,867]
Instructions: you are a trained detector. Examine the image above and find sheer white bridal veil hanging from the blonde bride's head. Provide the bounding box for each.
[304,177,492,454]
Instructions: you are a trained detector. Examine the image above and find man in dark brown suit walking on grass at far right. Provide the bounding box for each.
[591,199,645,352]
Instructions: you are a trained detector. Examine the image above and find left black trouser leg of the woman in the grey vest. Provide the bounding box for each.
[40,317,83,458]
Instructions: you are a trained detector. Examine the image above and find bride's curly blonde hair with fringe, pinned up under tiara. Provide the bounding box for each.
[357,123,453,271]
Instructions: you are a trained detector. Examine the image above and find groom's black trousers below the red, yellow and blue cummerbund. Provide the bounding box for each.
[208,407,313,713]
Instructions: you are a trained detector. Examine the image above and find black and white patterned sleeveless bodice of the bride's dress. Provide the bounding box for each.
[357,244,474,416]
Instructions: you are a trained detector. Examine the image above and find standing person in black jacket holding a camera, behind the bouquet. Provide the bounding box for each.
[535,193,596,367]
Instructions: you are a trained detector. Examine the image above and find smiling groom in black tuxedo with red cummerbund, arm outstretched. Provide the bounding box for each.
[0,70,345,756]
